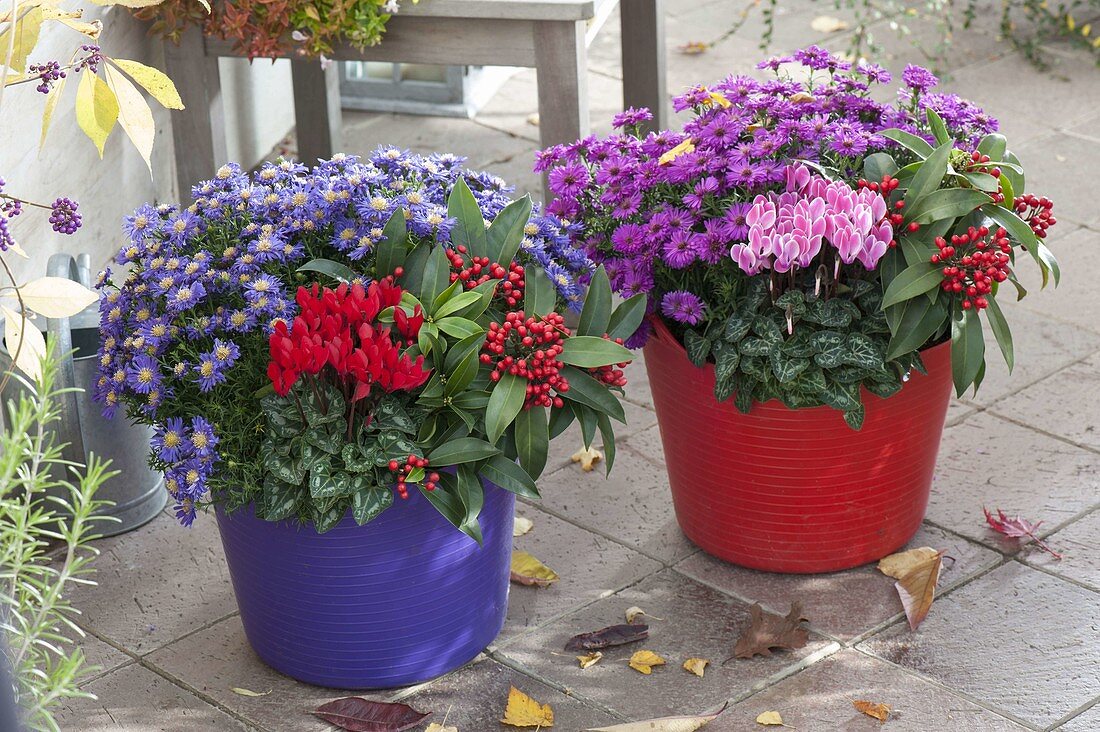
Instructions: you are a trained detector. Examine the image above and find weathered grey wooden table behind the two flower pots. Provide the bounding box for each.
[165,0,668,197]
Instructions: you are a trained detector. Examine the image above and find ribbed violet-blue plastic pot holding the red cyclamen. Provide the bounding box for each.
[218,483,516,689]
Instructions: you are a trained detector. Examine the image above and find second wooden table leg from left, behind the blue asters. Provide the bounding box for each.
[290,61,343,165]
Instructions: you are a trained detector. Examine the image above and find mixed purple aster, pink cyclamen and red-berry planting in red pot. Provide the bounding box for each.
[537,46,1059,429]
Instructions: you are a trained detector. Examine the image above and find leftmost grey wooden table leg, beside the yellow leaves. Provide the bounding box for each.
[164,28,227,200]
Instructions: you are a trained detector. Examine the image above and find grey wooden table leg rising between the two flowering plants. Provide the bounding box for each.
[535,21,591,201]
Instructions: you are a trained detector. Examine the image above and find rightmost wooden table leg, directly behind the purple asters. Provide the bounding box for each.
[619,0,669,129]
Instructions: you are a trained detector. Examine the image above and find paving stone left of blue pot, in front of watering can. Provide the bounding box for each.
[72,513,237,654]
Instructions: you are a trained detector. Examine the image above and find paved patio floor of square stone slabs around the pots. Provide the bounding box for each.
[55,0,1100,732]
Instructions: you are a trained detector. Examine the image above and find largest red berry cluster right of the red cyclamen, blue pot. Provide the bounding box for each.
[481,310,570,409]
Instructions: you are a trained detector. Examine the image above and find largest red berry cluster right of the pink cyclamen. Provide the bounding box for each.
[932,227,1012,310]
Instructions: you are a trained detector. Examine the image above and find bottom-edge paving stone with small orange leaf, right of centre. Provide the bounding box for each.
[706,649,1027,732]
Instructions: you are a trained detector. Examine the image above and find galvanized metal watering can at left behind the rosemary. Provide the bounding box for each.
[0,254,167,536]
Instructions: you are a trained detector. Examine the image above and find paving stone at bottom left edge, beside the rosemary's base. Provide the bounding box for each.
[57,664,251,732]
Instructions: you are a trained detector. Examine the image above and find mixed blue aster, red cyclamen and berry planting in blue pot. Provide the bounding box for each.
[102,149,645,539]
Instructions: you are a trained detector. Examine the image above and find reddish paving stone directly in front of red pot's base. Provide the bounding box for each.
[675,525,1000,643]
